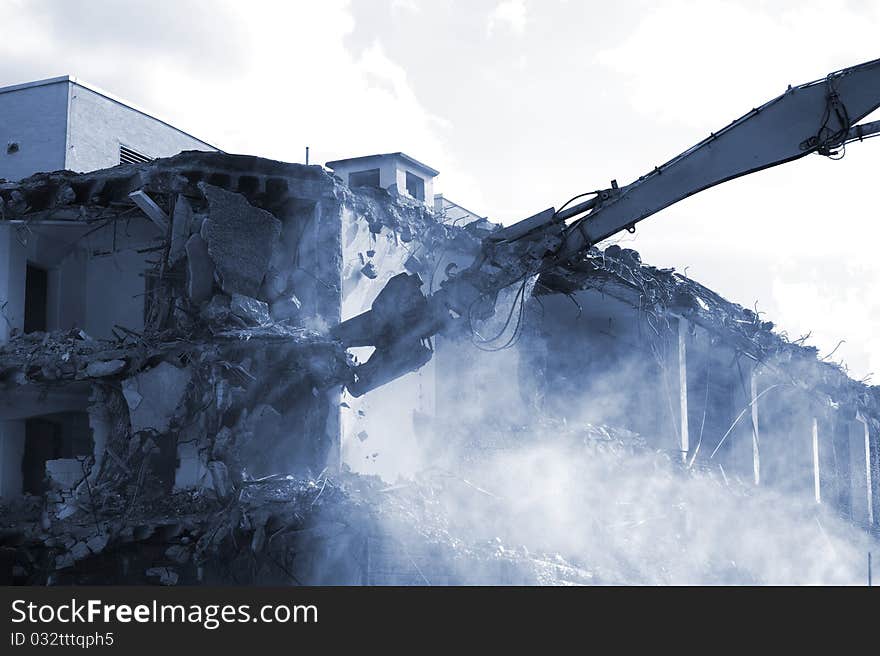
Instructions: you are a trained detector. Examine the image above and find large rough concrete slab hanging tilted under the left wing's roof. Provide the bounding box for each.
[199,183,281,297]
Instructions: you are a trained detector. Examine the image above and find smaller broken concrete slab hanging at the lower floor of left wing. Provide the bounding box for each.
[122,362,192,433]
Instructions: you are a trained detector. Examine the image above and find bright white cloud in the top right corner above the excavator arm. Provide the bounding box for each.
[595,0,880,129]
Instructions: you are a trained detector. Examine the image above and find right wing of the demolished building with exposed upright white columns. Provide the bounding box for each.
[527,246,880,530]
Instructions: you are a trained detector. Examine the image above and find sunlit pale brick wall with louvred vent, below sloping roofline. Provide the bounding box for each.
[66,84,215,171]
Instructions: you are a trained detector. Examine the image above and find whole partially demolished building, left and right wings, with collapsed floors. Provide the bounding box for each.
[0,152,880,584]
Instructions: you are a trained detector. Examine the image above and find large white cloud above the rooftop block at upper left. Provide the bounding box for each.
[0,0,463,192]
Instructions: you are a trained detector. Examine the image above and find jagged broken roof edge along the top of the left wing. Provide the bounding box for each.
[0,151,482,246]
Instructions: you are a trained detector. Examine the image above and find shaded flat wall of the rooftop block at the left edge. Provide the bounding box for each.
[0,80,68,180]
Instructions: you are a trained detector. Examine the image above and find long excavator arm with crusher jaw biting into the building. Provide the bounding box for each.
[333,59,880,396]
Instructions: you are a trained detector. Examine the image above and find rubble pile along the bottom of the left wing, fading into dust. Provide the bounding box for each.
[0,452,596,585]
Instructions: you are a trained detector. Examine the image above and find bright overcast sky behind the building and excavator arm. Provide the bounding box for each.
[0,0,880,382]
